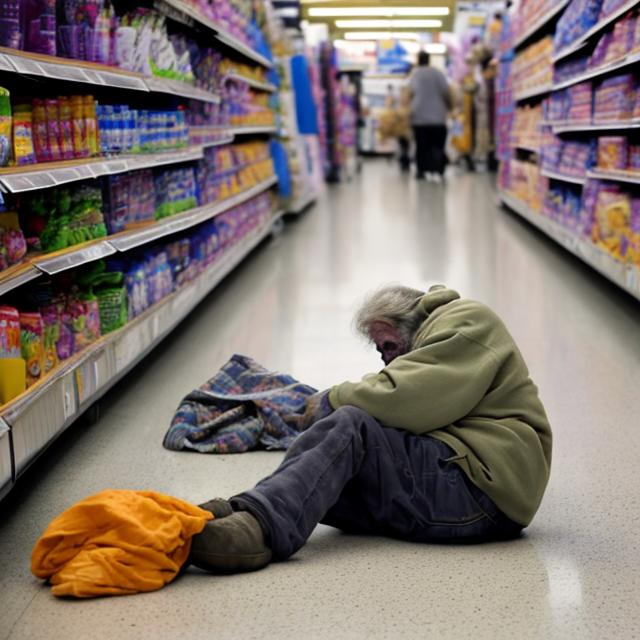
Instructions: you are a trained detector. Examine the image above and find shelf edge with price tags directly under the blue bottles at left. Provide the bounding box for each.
[0,145,204,193]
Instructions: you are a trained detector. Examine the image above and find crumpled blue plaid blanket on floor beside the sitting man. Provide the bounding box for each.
[162,355,316,453]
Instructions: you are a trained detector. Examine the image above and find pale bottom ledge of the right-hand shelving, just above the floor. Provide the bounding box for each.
[499,191,640,300]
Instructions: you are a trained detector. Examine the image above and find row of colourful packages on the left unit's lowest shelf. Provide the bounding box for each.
[0,193,273,403]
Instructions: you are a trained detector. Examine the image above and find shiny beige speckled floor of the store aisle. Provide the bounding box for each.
[0,161,640,640]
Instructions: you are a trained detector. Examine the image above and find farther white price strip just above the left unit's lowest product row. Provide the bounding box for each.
[107,176,278,251]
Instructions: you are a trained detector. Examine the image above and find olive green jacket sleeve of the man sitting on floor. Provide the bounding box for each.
[329,333,499,434]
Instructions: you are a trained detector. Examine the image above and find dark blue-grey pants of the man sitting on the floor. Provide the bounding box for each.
[231,407,522,560]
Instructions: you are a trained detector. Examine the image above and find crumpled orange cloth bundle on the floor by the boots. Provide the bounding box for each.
[31,490,213,598]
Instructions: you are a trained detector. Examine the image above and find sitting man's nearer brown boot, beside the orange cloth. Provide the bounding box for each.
[188,511,271,573]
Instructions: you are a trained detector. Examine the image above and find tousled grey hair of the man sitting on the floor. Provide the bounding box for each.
[354,285,425,345]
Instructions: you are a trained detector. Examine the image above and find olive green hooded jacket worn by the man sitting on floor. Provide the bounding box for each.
[329,286,551,526]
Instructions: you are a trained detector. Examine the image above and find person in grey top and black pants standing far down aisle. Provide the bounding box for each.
[409,51,452,181]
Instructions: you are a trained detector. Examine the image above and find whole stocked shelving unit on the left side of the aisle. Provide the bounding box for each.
[0,0,288,497]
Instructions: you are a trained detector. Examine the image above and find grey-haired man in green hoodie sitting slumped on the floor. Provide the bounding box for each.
[189,286,551,573]
